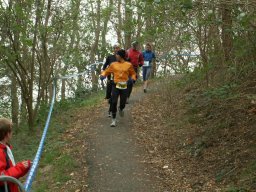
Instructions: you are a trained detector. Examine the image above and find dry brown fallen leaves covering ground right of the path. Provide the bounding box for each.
[132,79,255,192]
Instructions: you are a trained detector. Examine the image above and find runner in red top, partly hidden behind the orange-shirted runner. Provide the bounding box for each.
[127,41,144,103]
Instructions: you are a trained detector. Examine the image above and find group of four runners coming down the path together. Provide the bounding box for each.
[100,41,156,127]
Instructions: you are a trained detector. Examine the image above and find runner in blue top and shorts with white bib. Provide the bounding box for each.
[142,43,156,93]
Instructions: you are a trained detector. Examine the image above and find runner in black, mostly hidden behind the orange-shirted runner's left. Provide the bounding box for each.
[102,44,120,117]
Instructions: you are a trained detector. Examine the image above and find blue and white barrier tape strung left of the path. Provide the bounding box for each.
[24,62,103,192]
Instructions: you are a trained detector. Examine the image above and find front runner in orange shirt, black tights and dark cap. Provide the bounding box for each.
[100,49,136,127]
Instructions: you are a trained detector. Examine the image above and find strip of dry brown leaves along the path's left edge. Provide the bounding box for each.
[42,103,104,192]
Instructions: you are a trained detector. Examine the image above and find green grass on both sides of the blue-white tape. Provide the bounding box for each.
[11,91,104,192]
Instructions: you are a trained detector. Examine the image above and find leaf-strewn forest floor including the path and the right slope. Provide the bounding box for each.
[35,74,256,192]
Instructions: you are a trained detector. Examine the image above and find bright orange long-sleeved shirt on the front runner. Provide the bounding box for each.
[101,61,136,83]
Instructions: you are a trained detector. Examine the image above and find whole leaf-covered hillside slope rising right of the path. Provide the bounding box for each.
[132,78,256,191]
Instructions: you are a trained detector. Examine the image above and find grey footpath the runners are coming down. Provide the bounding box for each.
[87,88,158,192]
